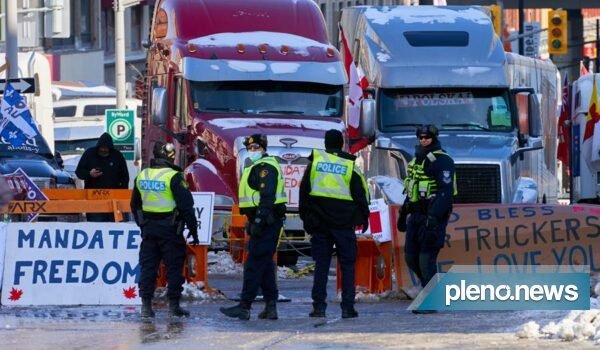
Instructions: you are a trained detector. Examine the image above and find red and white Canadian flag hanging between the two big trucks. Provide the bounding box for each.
[340,26,369,144]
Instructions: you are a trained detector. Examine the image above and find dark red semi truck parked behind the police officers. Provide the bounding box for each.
[142,0,347,259]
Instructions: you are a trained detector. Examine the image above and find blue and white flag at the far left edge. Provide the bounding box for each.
[0,83,40,147]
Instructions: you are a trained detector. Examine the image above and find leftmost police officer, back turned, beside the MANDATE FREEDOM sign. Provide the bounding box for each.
[131,142,199,318]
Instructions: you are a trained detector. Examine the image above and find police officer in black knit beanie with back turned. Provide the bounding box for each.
[299,130,369,318]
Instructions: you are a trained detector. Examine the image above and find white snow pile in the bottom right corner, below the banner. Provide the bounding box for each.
[517,298,600,344]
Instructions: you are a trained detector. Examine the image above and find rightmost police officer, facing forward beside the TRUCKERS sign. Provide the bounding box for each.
[397,125,456,313]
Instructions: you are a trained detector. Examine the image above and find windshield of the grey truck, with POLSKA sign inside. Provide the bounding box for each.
[378,88,513,132]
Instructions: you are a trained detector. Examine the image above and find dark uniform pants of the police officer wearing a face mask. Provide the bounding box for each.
[241,220,283,304]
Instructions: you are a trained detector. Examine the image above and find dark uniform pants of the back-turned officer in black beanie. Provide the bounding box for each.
[310,227,357,310]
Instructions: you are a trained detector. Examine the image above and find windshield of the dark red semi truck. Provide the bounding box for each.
[190,81,344,118]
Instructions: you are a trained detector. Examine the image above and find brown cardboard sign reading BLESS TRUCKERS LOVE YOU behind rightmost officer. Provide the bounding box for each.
[391,204,600,287]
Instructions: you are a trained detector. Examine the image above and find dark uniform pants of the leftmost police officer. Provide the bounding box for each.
[139,220,186,299]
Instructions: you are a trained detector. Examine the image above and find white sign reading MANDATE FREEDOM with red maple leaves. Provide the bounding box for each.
[2,222,141,306]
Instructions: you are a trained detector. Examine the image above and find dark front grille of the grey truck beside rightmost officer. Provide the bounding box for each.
[454,164,502,203]
